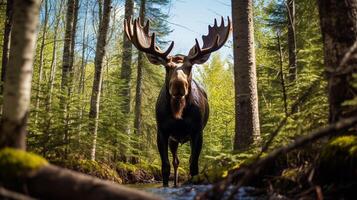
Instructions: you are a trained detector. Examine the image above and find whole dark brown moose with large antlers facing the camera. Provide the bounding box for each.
[124,17,232,187]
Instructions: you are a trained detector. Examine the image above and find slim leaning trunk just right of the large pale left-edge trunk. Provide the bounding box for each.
[35,0,49,124]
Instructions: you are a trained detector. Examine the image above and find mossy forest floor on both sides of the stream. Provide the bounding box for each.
[48,136,357,199]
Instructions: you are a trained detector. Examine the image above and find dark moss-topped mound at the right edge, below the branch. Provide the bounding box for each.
[318,136,357,182]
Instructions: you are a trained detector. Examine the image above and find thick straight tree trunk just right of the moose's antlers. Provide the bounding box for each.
[232,0,260,150]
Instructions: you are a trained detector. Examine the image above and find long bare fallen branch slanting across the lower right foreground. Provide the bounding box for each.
[195,116,357,200]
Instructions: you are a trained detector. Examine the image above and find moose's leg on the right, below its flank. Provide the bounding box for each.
[190,133,202,177]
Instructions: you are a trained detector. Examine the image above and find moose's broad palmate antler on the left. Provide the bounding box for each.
[124,18,174,61]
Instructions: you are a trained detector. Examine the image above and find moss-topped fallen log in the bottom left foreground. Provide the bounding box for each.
[0,148,159,200]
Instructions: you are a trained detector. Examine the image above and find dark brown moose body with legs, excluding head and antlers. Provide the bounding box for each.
[156,80,209,185]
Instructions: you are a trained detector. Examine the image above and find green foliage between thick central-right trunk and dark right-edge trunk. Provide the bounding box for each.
[255,0,328,146]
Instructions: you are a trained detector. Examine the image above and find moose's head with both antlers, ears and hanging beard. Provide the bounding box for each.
[124,17,231,119]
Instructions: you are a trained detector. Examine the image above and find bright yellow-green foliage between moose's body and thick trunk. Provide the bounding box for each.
[200,54,234,157]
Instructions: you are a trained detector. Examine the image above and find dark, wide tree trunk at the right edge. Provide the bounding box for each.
[318,0,357,123]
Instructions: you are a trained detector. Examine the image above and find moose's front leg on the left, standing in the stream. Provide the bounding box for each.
[157,132,170,187]
